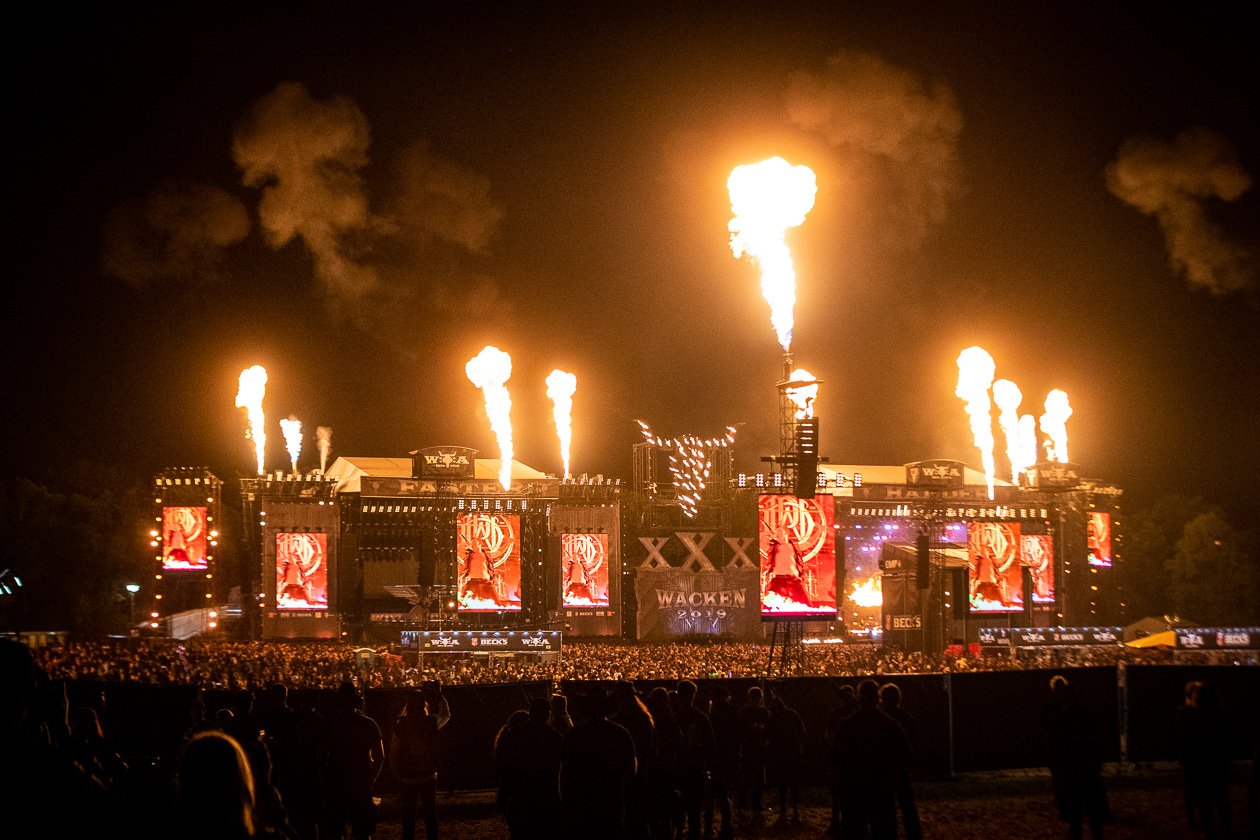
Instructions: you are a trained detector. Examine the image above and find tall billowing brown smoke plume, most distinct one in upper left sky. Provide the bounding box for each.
[232,82,382,305]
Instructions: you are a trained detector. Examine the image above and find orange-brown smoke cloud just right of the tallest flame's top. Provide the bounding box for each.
[786,50,963,243]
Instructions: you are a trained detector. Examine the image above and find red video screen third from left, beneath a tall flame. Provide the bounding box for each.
[455,513,520,612]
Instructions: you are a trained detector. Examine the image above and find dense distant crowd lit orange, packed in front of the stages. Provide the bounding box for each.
[24,639,1255,690]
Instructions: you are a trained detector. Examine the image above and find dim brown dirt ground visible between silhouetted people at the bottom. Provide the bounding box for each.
[377,767,1260,840]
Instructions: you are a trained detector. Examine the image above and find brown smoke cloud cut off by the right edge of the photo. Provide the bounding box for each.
[1106,128,1257,295]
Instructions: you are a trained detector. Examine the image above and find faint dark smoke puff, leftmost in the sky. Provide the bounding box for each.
[101,181,249,287]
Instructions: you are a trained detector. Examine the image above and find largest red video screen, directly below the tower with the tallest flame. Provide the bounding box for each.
[757,495,835,621]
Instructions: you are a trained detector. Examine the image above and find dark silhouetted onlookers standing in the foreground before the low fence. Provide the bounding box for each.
[0,640,1255,840]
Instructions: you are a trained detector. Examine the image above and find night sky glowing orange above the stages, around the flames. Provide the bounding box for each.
[5,3,1260,523]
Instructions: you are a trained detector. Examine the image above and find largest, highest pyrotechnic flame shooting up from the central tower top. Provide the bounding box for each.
[726,157,818,350]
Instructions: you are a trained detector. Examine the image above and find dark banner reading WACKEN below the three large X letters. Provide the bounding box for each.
[635,567,761,641]
